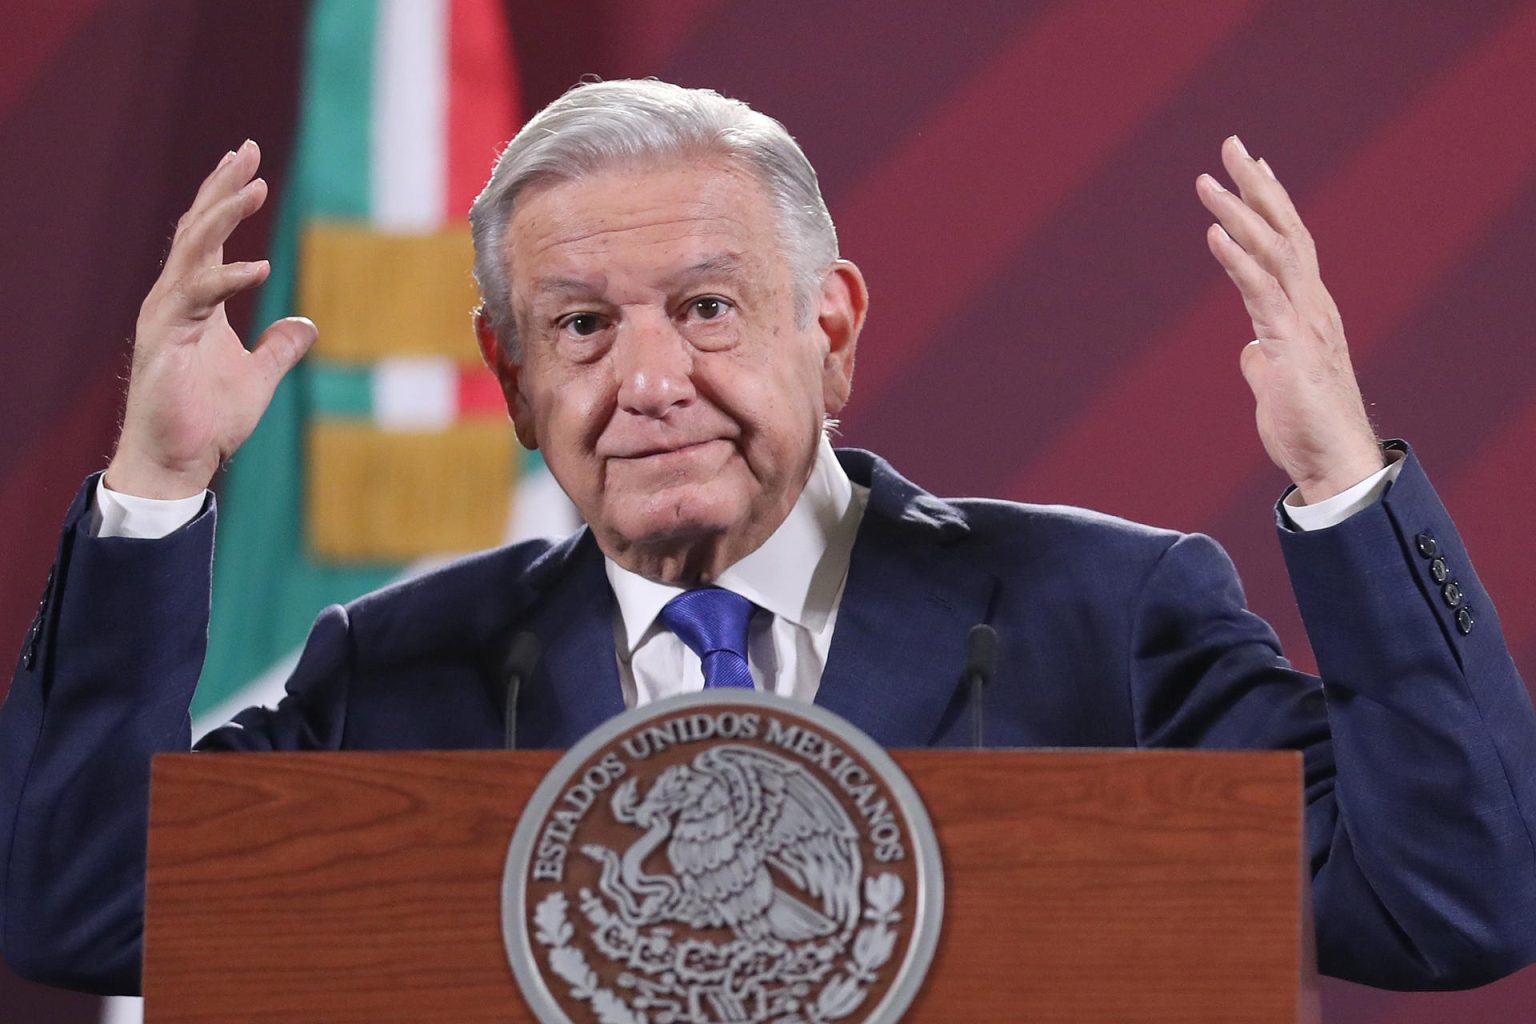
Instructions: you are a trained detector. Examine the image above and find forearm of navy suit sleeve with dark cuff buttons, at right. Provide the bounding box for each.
[1281,445,1536,987]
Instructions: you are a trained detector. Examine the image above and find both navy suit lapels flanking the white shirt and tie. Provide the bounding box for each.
[497,451,997,748]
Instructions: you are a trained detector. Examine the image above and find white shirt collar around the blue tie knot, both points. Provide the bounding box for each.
[604,436,863,660]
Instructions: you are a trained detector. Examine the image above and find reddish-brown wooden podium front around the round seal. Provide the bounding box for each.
[144,751,1318,1024]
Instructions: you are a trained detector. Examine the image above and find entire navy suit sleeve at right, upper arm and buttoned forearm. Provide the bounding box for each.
[1132,457,1536,989]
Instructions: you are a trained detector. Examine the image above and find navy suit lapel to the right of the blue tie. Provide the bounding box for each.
[816,453,997,746]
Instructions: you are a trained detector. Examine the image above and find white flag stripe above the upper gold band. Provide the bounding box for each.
[370,0,449,232]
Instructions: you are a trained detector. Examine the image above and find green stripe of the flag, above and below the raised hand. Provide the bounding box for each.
[192,0,401,715]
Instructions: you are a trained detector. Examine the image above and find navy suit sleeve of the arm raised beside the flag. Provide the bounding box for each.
[0,477,350,993]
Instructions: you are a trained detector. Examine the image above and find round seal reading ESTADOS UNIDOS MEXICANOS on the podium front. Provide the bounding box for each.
[502,691,943,1024]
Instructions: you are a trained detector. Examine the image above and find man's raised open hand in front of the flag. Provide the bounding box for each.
[106,141,316,499]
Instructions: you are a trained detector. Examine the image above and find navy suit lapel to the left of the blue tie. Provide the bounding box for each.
[506,530,624,748]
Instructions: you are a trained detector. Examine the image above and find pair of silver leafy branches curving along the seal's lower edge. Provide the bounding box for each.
[533,874,905,1024]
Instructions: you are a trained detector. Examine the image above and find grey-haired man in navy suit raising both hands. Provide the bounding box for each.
[0,83,1536,990]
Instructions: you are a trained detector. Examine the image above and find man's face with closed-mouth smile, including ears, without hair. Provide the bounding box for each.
[481,161,865,582]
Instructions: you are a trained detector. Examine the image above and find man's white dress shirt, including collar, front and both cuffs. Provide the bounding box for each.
[91,438,1402,708]
